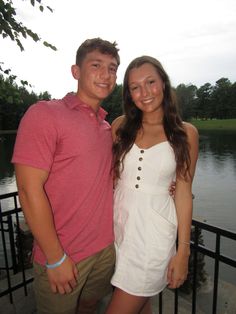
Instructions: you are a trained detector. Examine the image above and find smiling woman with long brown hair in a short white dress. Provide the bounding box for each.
[106,56,198,314]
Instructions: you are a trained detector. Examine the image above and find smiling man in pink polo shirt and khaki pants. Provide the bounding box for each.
[12,38,120,314]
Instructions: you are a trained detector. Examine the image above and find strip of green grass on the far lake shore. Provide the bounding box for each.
[191,119,236,131]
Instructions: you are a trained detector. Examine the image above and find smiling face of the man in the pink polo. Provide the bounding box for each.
[74,50,118,108]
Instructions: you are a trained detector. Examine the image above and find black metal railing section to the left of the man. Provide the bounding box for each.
[0,192,33,303]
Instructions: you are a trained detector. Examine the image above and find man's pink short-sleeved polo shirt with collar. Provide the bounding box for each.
[12,94,114,264]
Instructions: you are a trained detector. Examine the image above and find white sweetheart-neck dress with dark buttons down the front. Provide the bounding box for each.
[111,141,177,296]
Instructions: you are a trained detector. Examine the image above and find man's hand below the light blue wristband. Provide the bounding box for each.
[47,256,79,294]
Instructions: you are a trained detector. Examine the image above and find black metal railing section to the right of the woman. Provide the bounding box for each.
[158,220,236,314]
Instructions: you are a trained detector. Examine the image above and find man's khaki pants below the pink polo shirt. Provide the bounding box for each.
[34,244,115,314]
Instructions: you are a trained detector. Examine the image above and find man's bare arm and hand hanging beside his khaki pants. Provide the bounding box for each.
[15,164,77,294]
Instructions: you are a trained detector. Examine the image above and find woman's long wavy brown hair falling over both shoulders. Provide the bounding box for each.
[113,56,190,179]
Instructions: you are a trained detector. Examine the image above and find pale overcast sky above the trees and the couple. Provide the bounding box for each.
[0,0,236,98]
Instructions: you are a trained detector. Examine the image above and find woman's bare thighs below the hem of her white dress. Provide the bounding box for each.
[106,288,152,314]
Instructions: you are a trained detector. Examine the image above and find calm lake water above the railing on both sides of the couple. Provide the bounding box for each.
[0,131,236,231]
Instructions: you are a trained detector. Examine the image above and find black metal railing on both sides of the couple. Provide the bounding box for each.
[0,192,236,314]
